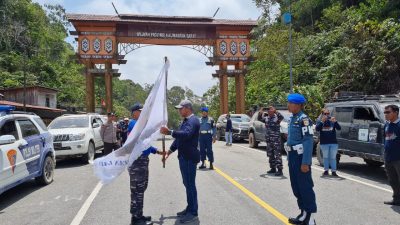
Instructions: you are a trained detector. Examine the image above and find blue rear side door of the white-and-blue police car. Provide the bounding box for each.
[16,118,46,174]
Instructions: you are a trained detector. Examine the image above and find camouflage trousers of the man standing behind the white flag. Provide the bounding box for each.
[129,155,149,218]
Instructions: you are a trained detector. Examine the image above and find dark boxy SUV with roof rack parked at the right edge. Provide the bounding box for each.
[317,96,400,167]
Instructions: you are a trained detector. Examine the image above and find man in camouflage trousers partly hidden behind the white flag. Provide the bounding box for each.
[128,103,163,225]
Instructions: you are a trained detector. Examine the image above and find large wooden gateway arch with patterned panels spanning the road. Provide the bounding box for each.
[67,14,257,113]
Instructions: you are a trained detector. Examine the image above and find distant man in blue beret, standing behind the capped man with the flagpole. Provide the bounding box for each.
[199,107,216,170]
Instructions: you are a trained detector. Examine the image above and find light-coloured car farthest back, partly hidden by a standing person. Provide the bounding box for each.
[216,114,250,141]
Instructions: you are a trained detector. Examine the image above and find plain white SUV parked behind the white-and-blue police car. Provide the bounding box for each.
[48,114,104,162]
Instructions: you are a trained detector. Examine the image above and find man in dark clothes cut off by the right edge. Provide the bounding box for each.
[384,105,400,206]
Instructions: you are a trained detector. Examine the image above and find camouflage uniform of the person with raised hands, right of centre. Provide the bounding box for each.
[263,112,283,170]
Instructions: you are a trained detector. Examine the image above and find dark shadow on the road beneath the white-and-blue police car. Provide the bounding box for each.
[0,179,43,214]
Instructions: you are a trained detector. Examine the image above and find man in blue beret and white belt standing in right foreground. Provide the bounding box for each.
[287,93,317,225]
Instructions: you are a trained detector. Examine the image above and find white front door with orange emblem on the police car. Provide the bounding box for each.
[0,119,29,189]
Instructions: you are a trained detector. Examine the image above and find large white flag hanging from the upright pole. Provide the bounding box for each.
[94,61,169,184]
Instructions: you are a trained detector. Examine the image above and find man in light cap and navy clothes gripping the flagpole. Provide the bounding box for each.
[160,100,200,223]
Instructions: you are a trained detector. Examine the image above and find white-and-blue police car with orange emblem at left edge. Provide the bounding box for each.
[0,105,56,194]
